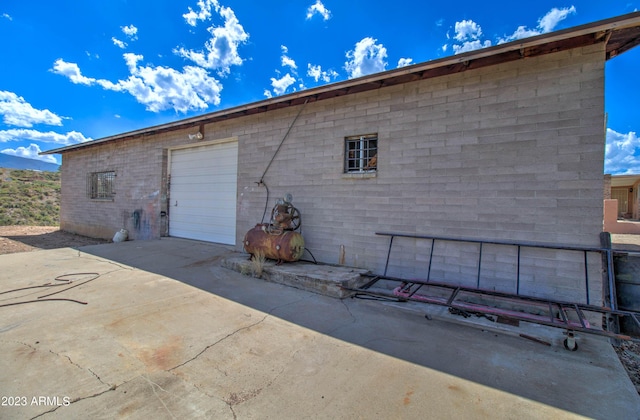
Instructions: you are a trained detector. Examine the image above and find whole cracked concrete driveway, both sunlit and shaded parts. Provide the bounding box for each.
[0,238,640,419]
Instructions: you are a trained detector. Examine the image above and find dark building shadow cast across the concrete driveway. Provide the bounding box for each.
[80,238,640,418]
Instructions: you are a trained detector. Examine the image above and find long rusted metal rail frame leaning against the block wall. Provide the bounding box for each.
[349,232,640,350]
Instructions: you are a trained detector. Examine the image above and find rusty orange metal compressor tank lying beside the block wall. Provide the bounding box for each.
[244,223,304,262]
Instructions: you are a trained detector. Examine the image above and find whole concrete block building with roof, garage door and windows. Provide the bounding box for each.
[46,13,640,303]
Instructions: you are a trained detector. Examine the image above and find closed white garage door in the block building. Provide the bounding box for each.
[169,141,238,245]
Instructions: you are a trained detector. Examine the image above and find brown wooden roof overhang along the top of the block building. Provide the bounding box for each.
[41,12,640,154]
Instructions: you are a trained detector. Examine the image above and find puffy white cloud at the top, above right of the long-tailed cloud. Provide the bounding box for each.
[173,4,249,75]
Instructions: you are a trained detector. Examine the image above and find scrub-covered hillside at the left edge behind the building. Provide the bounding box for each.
[0,168,60,226]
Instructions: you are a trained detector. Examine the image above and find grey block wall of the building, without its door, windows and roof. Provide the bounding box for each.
[61,44,604,306]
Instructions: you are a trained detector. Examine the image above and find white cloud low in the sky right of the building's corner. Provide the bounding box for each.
[604,128,640,175]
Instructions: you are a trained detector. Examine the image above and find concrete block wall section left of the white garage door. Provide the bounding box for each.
[60,140,166,239]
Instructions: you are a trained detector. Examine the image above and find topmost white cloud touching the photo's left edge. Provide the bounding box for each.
[0,91,63,127]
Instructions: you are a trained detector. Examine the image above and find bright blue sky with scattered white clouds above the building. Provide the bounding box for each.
[0,0,640,174]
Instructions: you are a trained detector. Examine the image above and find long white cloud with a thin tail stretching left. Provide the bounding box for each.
[52,53,222,112]
